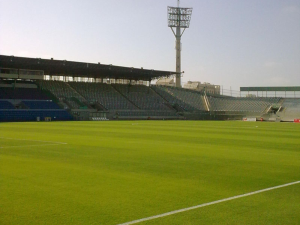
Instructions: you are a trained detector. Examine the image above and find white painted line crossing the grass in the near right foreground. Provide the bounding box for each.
[119,181,300,225]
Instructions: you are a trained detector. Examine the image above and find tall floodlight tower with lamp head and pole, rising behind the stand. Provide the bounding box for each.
[168,0,193,87]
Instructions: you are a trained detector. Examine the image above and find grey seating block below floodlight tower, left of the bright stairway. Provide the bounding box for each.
[152,86,206,111]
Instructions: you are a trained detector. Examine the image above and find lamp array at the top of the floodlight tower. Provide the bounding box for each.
[168,6,193,28]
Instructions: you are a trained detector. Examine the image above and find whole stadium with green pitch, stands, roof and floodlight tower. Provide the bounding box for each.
[0,1,300,225]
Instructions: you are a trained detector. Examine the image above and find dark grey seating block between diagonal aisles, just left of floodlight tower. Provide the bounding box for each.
[114,84,171,110]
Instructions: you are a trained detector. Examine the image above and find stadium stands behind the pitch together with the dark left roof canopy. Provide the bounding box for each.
[0,55,300,121]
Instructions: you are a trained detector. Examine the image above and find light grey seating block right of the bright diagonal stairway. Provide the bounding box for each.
[208,97,280,112]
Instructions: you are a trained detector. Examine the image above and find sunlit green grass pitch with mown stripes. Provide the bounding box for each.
[0,121,300,225]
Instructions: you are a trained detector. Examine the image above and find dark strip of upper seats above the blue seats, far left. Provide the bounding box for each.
[0,88,49,100]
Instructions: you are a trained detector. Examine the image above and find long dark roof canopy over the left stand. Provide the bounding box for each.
[0,55,176,81]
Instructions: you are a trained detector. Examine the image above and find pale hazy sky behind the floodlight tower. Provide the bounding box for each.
[0,0,300,90]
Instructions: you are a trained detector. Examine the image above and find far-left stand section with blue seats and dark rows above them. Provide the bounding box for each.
[0,81,73,122]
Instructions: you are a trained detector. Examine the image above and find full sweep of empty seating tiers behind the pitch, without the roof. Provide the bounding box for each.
[0,80,300,121]
